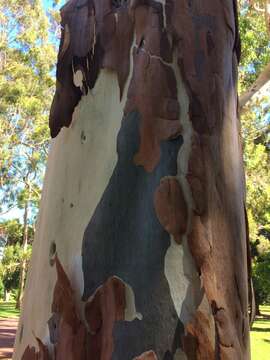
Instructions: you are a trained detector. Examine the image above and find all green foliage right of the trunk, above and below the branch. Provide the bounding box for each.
[238,0,270,305]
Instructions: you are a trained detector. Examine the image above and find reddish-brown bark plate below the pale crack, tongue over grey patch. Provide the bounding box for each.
[125,49,181,172]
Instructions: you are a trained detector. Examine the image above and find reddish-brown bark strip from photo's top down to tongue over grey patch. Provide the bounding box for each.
[125,1,181,172]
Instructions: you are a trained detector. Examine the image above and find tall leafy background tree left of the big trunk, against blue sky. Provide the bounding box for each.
[0,0,56,306]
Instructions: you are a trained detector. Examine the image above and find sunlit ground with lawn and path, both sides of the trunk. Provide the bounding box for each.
[0,303,270,360]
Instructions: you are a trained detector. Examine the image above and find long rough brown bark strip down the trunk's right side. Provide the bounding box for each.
[167,0,249,359]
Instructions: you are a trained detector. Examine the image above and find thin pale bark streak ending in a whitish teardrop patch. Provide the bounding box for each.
[164,53,201,326]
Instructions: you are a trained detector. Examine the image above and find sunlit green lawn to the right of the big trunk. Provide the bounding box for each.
[250,306,270,360]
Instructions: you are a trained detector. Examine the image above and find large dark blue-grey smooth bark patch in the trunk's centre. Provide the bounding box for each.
[82,112,183,360]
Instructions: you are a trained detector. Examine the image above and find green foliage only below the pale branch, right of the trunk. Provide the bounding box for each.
[245,107,270,305]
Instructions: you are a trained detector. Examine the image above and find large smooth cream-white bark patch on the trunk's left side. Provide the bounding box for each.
[13,70,125,360]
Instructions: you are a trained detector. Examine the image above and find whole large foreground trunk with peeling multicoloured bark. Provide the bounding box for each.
[14,0,250,360]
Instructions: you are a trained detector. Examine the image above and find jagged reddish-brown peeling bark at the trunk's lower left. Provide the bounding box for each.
[22,255,126,360]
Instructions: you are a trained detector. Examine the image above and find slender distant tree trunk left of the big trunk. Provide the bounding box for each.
[16,201,28,309]
